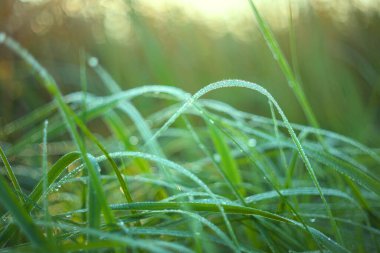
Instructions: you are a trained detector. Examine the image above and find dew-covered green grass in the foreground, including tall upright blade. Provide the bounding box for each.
[0,1,380,252]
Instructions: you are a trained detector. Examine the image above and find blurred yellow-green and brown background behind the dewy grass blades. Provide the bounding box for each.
[0,0,380,146]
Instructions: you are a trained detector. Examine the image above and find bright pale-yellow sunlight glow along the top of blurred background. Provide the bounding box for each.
[22,0,380,43]
